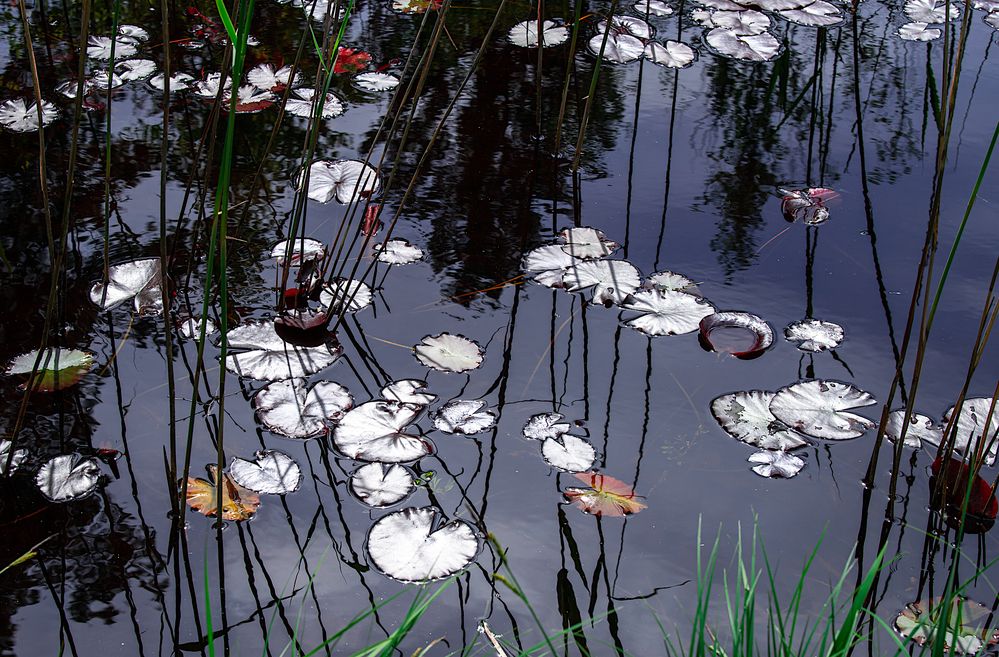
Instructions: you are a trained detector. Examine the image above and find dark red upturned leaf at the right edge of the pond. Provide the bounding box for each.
[930,457,999,533]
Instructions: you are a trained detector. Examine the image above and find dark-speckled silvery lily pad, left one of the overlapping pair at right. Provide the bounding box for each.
[711,390,808,451]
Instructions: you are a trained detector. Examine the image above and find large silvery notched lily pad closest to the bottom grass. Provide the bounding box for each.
[368,507,479,582]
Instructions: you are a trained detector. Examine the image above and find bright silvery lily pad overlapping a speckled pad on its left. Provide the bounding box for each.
[770,381,877,440]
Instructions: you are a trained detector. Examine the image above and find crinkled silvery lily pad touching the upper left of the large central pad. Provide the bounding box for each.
[253,379,354,439]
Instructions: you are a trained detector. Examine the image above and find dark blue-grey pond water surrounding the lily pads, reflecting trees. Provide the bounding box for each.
[0,0,999,655]
